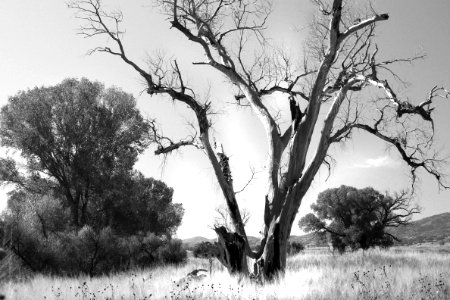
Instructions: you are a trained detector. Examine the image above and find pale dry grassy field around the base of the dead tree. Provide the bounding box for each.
[0,245,450,300]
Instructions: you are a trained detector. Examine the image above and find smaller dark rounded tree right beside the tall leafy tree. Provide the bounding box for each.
[88,172,184,237]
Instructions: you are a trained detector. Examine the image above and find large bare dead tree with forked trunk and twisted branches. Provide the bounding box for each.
[71,0,449,278]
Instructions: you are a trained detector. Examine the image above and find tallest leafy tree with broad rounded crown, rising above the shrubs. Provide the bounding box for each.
[0,79,149,226]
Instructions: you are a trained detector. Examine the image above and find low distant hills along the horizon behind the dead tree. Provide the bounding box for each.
[183,212,450,249]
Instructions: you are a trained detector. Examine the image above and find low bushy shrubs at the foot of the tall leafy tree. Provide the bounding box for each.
[0,179,186,276]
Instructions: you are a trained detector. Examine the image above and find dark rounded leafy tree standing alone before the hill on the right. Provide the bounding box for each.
[299,185,419,252]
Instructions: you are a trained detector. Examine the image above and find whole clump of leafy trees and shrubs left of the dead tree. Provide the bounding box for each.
[0,79,186,276]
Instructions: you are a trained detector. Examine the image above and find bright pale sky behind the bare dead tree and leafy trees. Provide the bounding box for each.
[0,0,450,238]
